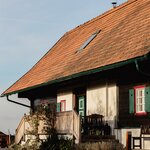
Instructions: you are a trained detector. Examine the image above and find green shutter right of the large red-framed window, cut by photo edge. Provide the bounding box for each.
[145,87,150,112]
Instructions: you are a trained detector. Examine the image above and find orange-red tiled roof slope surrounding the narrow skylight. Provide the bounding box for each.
[3,0,150,95]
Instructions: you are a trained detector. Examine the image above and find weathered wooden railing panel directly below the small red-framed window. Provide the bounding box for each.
[56,111,81,143]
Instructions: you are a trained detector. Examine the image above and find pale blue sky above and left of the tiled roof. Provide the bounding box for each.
[0,0,127,134]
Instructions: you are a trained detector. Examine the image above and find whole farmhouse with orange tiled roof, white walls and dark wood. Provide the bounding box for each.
[2,0,150,146]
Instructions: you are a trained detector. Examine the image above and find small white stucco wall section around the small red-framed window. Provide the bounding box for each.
[57,91,73,111]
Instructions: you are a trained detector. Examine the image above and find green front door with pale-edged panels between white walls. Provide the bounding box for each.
[77,96,86,117]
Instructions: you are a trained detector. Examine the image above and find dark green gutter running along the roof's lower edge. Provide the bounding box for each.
[1,52,150,97]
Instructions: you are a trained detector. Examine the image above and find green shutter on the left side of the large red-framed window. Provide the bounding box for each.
[129,89,134,113]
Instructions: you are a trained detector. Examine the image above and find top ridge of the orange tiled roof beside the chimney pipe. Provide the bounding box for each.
[66,0,138,34]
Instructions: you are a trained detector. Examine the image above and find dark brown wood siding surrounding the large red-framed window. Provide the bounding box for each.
[118,82,150,127]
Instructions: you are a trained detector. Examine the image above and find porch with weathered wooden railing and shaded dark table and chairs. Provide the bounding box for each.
[15,110,112,144]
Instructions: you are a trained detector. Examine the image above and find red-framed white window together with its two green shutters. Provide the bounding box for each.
[129,85,150,115]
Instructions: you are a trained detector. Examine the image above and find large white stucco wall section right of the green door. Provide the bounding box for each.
[86,84,117,134]
